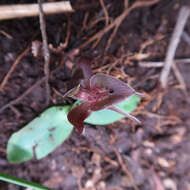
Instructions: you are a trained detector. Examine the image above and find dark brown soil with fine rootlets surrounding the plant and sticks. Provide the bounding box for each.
[0,0,190,190]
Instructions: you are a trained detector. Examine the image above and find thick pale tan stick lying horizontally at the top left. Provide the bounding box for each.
[0,1,74,20]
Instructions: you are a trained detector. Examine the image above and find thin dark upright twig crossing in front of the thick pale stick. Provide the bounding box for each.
[38,0,50,105]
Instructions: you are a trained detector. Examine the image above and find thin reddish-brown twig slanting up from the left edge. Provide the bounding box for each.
[0,46,30,92]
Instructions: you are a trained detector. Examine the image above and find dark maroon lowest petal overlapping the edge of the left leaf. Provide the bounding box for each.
[67,102,91,134]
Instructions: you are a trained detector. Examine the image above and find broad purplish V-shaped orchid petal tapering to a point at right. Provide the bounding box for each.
[90,73,135,111]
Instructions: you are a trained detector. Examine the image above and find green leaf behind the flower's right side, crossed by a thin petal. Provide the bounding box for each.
[85,95,140,125]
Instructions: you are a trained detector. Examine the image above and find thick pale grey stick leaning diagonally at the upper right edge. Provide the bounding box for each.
[160,6,190,88]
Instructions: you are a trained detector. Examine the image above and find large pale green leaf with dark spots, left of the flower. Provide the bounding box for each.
[7,106,73,163]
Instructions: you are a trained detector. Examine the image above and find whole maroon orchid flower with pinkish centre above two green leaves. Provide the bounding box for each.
[66,58,142,134]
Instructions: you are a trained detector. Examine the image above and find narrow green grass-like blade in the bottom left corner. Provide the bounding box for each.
[0,173,51,190]
